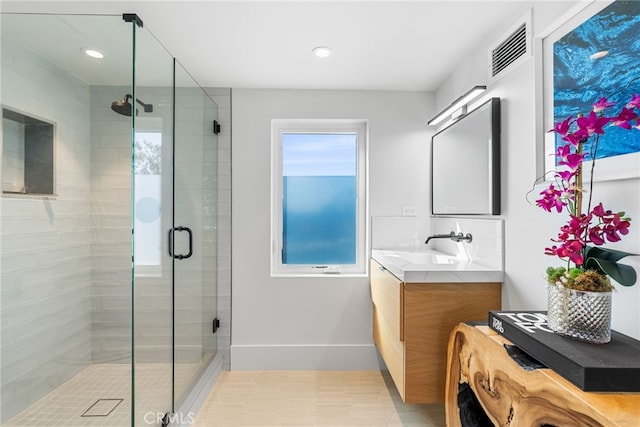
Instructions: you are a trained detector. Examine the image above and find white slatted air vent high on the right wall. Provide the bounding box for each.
[489,14,531,80]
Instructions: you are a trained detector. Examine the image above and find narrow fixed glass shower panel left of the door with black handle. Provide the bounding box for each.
[131,15,175,426]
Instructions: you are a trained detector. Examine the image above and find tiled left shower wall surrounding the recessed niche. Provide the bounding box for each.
[0,38,91,421]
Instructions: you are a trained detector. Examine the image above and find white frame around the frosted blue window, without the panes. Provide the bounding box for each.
[271,119,369,277]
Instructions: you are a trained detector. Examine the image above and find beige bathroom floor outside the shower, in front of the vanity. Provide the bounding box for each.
[194,371,445,427]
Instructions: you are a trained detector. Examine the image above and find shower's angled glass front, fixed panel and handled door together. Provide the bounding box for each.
[132,19,217,425]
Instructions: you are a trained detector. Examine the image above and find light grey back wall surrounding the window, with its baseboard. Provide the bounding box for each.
[231,90,433,369]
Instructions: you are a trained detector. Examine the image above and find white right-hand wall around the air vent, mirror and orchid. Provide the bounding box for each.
[436,2,640,338]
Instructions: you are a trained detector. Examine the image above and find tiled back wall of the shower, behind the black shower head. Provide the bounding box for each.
[91,86,217,363]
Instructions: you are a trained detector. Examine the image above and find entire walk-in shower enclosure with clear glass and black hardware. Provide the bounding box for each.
[0,13,218,426]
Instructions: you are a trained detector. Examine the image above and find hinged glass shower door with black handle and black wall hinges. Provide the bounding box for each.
[170,61,218,414]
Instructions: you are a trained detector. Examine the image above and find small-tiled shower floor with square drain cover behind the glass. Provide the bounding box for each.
[3,363,201,427]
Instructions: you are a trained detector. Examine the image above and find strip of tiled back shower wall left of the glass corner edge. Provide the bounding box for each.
[91,87,131,363]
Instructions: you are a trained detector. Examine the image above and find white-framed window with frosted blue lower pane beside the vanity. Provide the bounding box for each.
[271,120,367,276]
